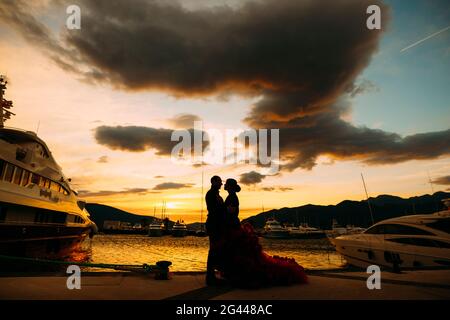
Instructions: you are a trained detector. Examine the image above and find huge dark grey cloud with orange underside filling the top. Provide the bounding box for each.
[2,0,388,100]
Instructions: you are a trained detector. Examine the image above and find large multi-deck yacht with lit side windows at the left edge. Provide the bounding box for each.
[0,79,97,258]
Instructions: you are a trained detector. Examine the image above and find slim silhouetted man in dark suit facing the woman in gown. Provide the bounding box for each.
[205,176,225,285]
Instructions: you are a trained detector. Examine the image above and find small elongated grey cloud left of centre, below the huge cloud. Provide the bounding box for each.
[94,126,208,156]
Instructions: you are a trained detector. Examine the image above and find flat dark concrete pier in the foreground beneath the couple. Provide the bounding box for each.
[0,270,450,300]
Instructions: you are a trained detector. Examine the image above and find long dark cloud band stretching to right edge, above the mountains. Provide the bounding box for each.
[272,108,450,170]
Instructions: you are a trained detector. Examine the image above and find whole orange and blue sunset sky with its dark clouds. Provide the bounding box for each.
[0,0,450,222]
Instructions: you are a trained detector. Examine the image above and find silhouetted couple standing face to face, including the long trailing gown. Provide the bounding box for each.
[206,176,307,288]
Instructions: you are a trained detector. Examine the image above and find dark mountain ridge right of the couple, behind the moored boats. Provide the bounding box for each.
[243,192,450,230]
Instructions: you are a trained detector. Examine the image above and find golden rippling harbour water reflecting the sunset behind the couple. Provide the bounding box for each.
[78,234,345,271]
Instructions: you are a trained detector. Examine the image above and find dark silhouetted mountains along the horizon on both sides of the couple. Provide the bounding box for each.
[86,192,450,230]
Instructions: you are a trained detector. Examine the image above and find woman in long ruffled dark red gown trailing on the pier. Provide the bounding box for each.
[216,179,307,288]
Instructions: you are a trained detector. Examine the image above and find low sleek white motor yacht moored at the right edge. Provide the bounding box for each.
[331,199,450,269]
